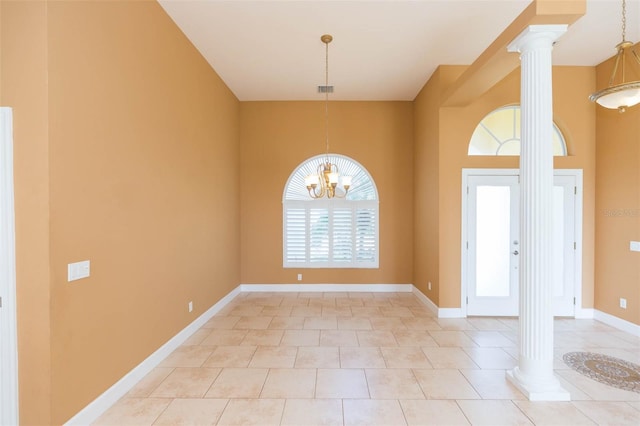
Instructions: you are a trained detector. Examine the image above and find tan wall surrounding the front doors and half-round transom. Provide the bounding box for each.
[415,66,595,308]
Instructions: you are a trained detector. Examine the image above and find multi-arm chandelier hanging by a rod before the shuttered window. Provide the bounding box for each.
[304,34,352,198]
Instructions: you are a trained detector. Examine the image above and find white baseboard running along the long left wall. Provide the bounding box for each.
[65,287,241,426]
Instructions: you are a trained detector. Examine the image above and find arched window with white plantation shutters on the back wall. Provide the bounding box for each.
[282,154,378,268]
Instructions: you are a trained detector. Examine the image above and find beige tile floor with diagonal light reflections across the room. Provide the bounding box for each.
[95,293,640,426]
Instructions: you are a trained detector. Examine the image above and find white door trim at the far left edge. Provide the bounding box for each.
[0,107,19,425]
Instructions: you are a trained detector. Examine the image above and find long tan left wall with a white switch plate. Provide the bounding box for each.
[2,2,240,424]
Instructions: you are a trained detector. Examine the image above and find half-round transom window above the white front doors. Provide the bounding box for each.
[468,105,567,156]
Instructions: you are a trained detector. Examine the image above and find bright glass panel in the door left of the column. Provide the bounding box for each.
[475,186,511,297]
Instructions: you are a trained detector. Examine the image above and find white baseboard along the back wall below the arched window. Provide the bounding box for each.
[240,284,413,293]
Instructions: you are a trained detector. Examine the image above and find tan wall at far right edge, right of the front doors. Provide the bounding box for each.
[595,44,640,325]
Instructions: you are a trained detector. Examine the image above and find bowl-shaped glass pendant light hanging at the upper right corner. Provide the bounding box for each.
[589,0,640,113]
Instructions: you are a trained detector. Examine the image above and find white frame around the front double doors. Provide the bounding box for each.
[460,168,584,317]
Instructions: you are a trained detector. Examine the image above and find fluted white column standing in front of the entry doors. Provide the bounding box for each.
[507,25,569,401]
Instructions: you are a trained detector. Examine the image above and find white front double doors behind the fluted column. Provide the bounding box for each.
[462,170,580,316]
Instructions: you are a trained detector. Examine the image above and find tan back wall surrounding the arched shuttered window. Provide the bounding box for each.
[241,102,413,284]
